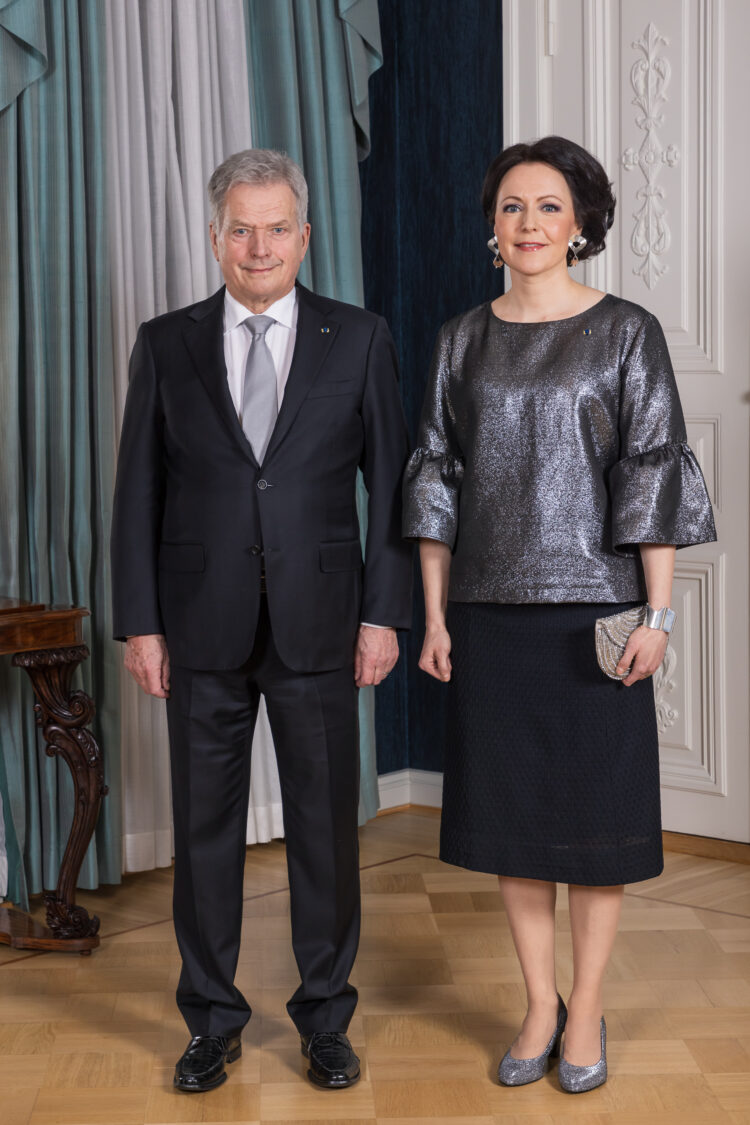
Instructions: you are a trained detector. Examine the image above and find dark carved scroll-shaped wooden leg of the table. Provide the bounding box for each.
[6,645,107,952]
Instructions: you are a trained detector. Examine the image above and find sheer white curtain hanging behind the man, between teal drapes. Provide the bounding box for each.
[106,0,283,871]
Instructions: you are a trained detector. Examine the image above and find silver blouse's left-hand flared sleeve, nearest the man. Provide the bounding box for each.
[403,329,463,550]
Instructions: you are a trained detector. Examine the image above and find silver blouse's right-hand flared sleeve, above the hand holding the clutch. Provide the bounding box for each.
[608,315,716,556]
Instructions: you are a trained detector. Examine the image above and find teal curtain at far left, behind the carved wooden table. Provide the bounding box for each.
[0,0,121,905]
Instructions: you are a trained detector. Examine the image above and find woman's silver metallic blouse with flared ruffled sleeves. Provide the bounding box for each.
[404,295,716,602]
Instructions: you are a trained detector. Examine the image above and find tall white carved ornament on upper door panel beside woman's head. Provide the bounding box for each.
[622,24,680,289]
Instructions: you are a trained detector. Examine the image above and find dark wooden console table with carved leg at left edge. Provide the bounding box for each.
[0,597,107,954]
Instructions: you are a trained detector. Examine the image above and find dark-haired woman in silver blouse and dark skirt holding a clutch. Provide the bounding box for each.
[404,137,715,1092]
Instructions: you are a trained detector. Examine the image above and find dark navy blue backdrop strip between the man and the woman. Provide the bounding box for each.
[360,0,503,773]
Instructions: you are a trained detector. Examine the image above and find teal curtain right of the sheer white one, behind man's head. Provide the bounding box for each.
[246,0,382,821]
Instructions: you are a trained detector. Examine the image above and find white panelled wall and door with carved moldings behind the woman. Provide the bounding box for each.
[504,0,750,840]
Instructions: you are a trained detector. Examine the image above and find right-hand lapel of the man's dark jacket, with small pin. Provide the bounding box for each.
[264,285,338,460]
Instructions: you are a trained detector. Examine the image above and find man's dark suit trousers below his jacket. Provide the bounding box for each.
[168,597,360,1035]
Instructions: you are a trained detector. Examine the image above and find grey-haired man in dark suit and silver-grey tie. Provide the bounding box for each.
[112,150,412,1091]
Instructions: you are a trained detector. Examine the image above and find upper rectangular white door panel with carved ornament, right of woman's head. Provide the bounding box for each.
[618,0,724,375]
